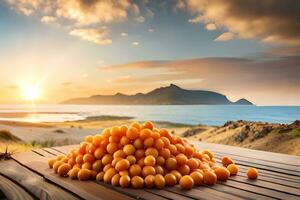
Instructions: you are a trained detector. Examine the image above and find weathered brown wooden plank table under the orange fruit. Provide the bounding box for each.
[0,142,300,200]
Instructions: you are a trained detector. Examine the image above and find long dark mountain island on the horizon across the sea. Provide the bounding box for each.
[62,84,253,105]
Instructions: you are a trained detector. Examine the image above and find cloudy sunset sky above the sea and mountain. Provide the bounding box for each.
[0,0,300,105]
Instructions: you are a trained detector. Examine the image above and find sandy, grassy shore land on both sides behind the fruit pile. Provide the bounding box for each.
[0,115,300,155]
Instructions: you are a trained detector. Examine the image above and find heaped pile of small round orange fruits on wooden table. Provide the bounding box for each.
[48,121,257,189]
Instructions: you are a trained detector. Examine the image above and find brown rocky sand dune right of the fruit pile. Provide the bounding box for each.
[183,121,300,155]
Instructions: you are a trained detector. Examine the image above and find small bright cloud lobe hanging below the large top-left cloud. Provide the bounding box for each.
[69,28,112,45]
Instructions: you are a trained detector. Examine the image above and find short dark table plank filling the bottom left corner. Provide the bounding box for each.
[0,175,34,200]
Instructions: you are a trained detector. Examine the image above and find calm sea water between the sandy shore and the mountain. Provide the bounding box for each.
[0,105,300,125]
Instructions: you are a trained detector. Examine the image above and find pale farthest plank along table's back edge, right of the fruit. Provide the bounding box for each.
[190,140,300,167]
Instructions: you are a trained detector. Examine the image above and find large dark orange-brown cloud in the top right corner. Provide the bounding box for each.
[182,0,300,45]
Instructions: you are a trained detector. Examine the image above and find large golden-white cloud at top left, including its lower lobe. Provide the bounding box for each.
[5,0,140,44]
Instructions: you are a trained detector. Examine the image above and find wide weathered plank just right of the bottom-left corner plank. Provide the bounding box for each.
[0,160,78,200]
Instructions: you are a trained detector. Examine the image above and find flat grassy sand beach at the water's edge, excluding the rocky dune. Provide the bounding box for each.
[0,116,193,152]
